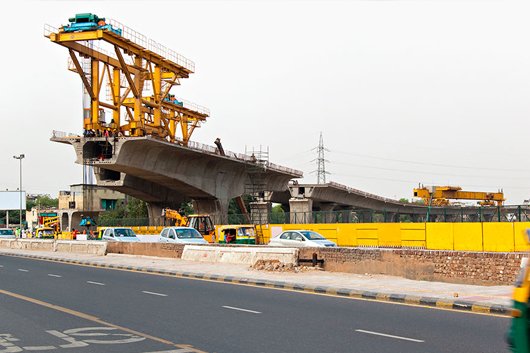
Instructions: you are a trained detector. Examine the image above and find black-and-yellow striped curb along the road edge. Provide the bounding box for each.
[0,252,512,316]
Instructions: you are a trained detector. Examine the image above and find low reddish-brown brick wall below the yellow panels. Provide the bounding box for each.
[299,248,528,285]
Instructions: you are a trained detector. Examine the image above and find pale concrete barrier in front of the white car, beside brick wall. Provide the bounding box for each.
[182,245,298,265]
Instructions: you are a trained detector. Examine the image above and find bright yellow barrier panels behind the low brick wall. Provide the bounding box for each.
[263,222,530,252]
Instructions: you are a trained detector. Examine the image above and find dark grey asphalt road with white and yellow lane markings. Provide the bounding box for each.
[0,255,509,353]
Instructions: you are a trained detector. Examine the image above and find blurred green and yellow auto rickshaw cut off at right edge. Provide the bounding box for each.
[506,229,530,353]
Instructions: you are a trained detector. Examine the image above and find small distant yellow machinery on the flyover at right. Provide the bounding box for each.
[414,186,505,206]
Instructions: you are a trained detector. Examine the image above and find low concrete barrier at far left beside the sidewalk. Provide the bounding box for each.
[0,239,107,256]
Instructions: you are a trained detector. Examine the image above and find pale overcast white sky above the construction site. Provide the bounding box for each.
[0,0,530,204]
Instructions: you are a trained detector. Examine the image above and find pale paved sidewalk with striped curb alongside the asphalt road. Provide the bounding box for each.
[0,249,513,315]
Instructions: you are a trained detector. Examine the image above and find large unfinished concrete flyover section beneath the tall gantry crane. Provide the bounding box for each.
[51,132,303,219]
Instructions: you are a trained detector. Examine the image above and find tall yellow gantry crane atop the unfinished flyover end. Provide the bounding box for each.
[44,13,209,145]
